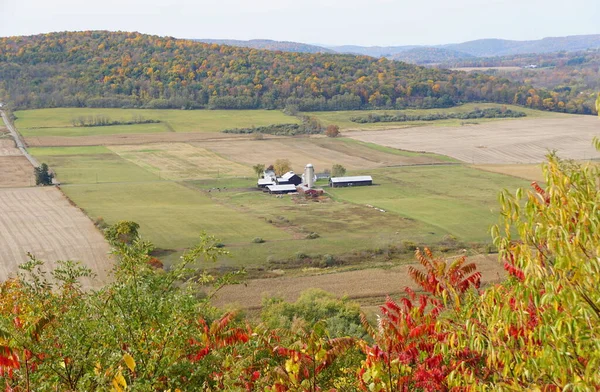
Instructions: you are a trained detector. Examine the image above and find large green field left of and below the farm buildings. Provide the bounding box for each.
[63,182,289,249]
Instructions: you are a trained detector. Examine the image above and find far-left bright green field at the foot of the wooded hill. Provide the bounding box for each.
[15,108,299,136]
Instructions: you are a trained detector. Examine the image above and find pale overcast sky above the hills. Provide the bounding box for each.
[0,0,600,46]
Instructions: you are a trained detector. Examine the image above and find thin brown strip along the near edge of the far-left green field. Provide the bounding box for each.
[25,132,248,147]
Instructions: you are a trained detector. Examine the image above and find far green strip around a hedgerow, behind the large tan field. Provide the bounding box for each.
[305,103,560,129]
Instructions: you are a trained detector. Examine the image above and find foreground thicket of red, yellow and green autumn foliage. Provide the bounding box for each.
[0,146,600,392]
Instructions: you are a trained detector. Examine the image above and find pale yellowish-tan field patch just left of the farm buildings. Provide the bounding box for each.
[110,143,253,180]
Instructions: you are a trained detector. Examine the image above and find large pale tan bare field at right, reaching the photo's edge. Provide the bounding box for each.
[344,115,600,164]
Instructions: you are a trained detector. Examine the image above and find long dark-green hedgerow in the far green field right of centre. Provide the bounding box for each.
[350,108,527,124]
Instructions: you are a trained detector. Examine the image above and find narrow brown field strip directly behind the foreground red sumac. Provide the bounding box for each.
[212,255,505,309]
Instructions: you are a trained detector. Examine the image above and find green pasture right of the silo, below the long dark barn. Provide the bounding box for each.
[329,165,528,242]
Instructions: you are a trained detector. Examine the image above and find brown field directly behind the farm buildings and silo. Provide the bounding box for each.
[202,137,446,171]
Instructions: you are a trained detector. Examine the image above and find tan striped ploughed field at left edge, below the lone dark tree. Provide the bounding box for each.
[0,187,111,287]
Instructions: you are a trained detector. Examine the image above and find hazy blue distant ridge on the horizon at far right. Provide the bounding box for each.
[441,34,600,57]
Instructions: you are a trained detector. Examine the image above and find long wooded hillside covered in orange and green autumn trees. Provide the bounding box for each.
[0,31,590,113]
